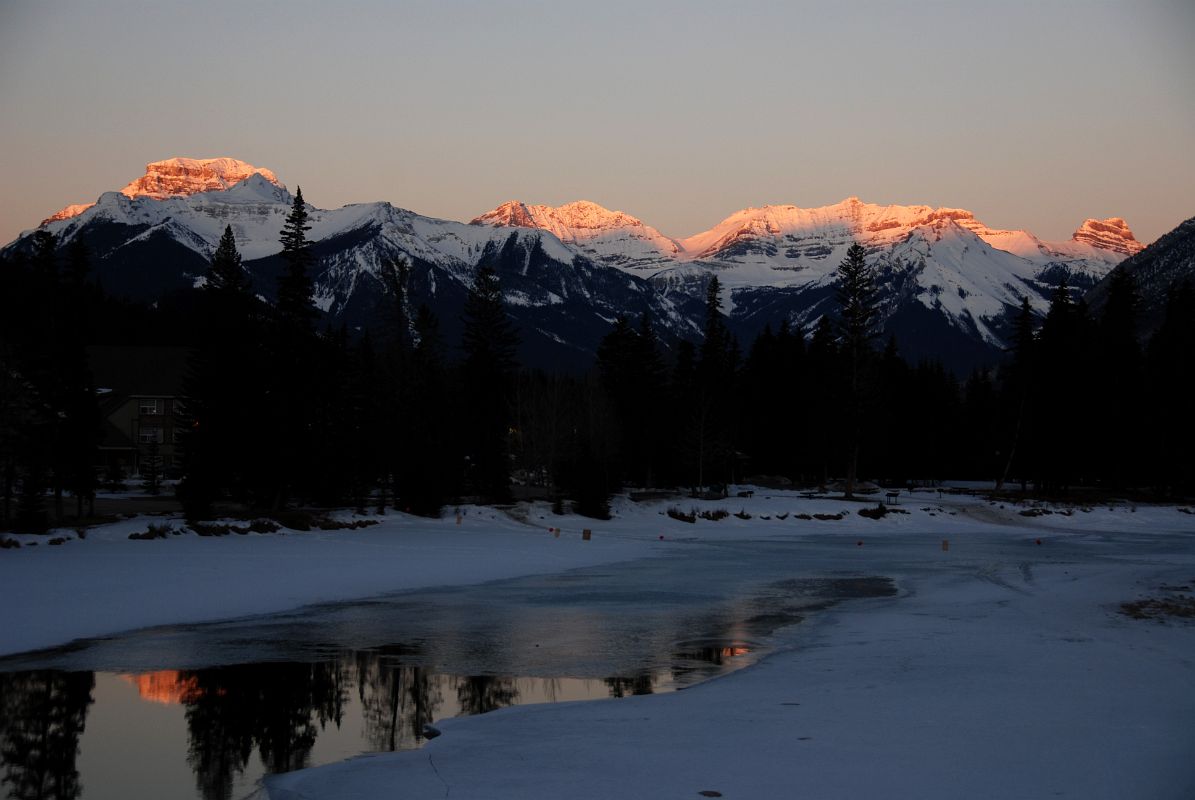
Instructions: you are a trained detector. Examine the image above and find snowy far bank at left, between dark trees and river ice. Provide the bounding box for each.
[0,507,652,655]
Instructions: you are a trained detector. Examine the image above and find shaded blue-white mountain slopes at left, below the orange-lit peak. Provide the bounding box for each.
[5,173,700,368]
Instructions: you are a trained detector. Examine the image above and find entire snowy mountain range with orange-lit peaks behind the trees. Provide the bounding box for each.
[4,158,1166,371]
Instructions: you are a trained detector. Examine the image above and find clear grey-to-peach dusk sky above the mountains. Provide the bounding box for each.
[0,0,1195,242]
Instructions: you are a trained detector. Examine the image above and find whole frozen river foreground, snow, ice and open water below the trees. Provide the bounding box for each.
[0,495,1195,800]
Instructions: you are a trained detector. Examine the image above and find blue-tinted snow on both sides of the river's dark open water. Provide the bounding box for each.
[0,490,1195,800]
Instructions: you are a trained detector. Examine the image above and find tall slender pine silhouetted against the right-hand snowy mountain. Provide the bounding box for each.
[837,243,880,497]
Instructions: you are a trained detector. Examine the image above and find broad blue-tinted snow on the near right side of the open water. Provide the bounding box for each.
[266,500,1195,800]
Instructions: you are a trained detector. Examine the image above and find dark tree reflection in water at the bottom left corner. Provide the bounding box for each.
[0,670,96,800]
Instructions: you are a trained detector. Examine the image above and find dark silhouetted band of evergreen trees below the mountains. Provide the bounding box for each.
[0,214,1195,531]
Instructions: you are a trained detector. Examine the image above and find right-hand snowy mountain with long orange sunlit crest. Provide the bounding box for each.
[473,197,1141,368]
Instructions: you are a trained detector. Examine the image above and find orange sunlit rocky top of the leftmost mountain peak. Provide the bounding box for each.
[42,157,289,225]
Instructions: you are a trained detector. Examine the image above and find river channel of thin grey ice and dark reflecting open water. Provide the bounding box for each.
[0,541,896,799]
